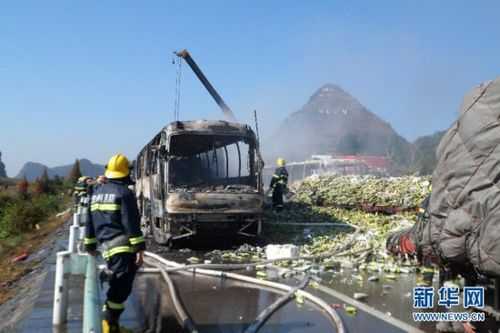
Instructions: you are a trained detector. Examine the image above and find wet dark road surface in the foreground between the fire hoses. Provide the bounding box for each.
[135,235,422,333]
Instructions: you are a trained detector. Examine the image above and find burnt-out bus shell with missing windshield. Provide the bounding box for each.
[134,120,264,245]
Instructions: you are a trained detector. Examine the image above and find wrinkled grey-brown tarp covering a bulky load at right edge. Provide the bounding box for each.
[419,77,500,276]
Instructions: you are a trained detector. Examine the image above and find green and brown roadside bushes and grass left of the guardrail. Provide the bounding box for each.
[0,166,80,304]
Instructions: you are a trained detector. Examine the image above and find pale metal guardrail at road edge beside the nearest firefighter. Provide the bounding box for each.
[52,209,102,333]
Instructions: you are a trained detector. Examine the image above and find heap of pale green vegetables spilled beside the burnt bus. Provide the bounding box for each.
[189,175,430,281]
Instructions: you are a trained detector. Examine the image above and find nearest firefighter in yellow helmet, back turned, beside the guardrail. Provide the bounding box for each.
[84,154,146,333]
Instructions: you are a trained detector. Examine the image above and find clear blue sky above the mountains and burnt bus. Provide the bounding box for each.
[0,0,500,176]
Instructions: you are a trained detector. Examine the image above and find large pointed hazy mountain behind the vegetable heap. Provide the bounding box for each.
[264,84,414,169]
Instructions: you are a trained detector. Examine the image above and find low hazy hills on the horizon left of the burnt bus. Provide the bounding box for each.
[17,158,104,181]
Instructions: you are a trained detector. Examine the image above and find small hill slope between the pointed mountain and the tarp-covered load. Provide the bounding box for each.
[412,131,446,175]
